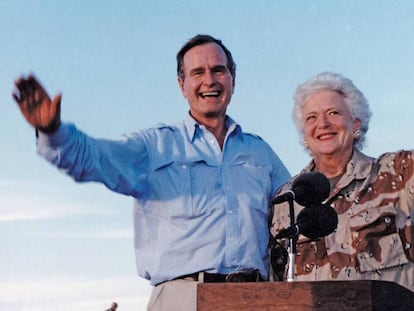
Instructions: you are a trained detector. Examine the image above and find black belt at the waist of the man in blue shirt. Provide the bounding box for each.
[175,271,264,283]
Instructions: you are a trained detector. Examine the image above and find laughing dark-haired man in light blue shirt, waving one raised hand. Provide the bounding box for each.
[13,35,289,310]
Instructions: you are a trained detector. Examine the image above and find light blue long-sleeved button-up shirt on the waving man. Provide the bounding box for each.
[37,117,290,285]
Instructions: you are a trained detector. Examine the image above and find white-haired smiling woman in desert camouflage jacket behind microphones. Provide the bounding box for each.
[270,72,414,291]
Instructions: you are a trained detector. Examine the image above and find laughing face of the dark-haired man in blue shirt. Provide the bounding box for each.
[178,43,235,123]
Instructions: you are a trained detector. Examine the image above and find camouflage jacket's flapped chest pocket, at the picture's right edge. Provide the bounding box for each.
[349,204,408,272]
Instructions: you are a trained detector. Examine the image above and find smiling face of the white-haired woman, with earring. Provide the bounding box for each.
[302,90,360,158]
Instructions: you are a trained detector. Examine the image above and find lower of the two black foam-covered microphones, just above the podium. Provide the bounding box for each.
[276,204,338,240]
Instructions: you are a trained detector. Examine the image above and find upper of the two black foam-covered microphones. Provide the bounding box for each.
[272,172,331,206]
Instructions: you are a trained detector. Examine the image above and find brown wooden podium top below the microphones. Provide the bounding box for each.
[197,281,414,311]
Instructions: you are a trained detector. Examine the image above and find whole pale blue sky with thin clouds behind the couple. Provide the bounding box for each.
[0,0,414,311]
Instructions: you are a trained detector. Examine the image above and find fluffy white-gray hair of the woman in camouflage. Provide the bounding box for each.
[292,72,372,150]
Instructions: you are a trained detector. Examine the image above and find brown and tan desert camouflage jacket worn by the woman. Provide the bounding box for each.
[269,150,414,291]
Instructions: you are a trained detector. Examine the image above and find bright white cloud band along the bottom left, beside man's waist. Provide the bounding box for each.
[0,275,151,311]
